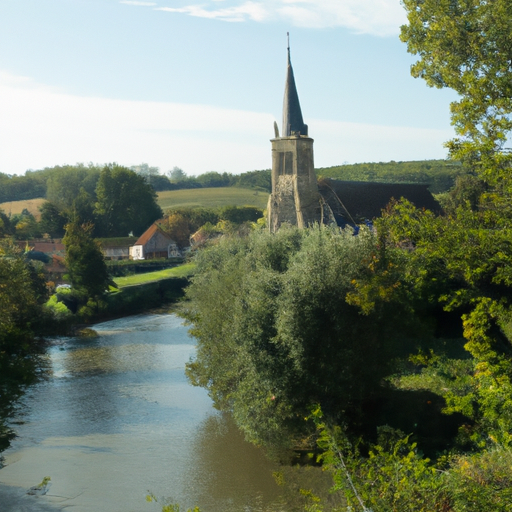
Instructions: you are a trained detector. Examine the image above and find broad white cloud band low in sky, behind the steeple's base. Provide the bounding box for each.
[0,71,453,174]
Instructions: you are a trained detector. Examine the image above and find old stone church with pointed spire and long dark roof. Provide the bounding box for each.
[267,44,440,232]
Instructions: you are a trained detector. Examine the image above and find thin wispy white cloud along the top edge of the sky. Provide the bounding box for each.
[154,0,406,36]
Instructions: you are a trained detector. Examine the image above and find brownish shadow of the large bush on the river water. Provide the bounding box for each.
[178,414,343,512]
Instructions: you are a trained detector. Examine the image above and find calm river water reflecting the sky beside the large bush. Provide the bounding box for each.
[0,314,308,512]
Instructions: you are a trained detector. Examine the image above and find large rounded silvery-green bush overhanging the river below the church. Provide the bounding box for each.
[185,227,438,452]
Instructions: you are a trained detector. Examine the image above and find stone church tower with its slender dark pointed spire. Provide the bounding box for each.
[267,40,321,232]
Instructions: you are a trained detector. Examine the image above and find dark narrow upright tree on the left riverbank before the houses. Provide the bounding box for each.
[62,222,111,303]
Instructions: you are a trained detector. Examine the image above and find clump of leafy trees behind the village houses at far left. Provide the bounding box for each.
[0,165,163,239]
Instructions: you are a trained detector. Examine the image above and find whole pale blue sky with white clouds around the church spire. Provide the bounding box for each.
[0,0,456,175]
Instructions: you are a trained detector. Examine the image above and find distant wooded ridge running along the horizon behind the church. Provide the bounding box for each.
[0,160,464,203]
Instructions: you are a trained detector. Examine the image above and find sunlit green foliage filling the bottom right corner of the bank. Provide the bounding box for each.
[311,408,512,512]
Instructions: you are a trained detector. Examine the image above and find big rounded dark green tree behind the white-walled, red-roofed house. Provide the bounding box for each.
[95,164,163,236]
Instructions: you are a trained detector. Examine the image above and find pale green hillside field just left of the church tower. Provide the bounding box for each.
[158,187,268,211]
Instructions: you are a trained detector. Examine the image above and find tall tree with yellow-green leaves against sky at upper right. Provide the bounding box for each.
[401,0,512,188]
